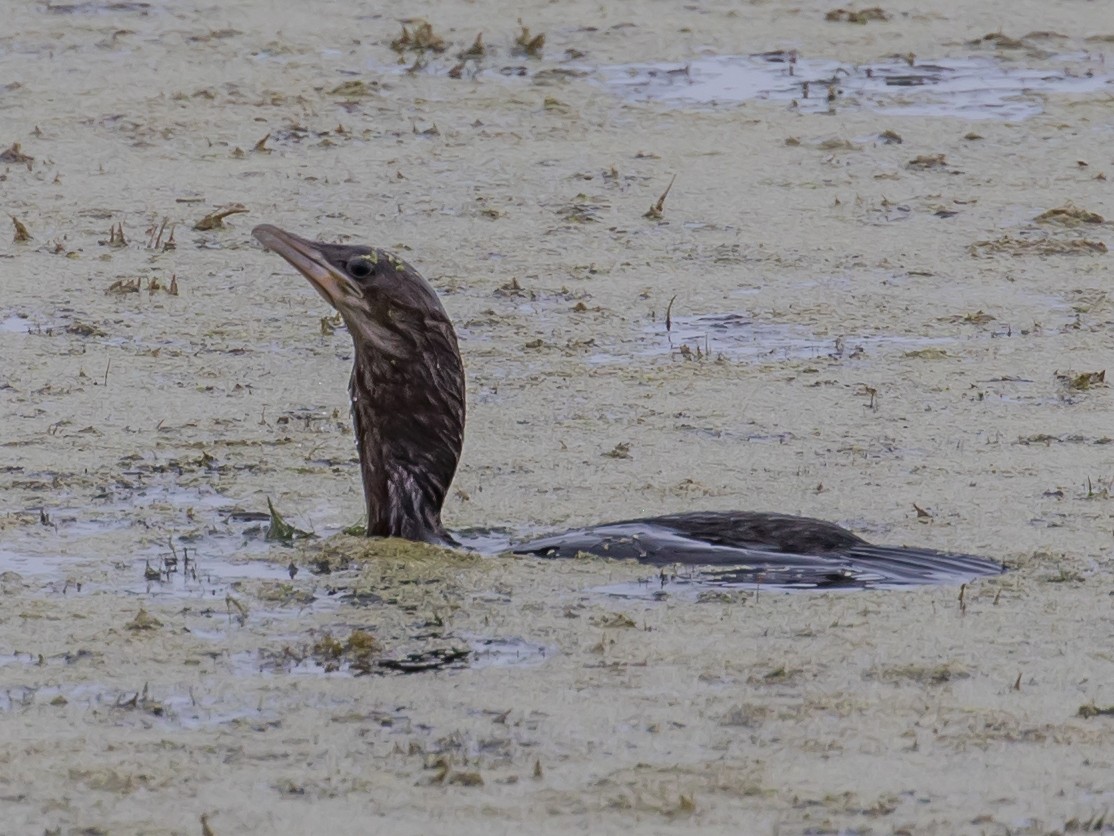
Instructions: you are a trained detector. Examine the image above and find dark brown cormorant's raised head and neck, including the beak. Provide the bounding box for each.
[252,225,465,543]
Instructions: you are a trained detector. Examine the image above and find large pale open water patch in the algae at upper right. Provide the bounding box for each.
[599,52,1111,121]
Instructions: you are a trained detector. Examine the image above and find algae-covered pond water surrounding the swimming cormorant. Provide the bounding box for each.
[0,0,1114,834]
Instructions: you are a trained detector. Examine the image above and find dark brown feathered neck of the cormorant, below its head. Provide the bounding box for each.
[350,325,465,545]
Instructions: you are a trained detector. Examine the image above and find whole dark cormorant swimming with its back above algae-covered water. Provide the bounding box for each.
[252,224,1004,586]
